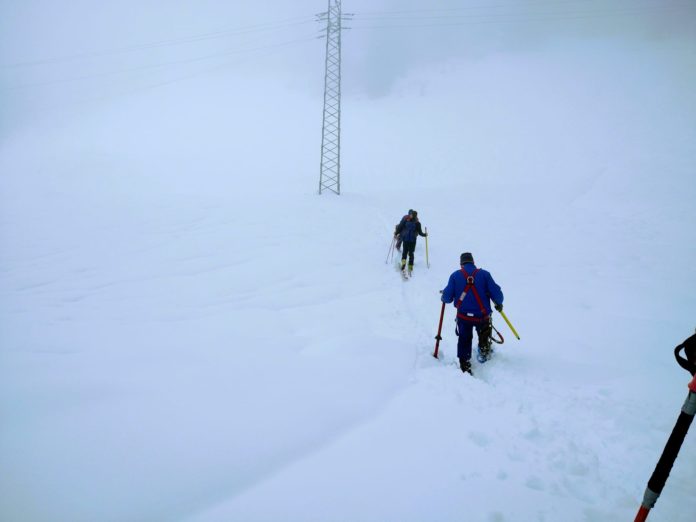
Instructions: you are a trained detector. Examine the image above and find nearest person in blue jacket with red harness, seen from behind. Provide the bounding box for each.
[442,252,503,374]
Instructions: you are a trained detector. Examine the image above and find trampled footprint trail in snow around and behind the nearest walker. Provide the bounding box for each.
[378,214,672,521]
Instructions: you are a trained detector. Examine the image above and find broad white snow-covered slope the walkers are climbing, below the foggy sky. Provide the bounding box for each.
[0,36,696,522]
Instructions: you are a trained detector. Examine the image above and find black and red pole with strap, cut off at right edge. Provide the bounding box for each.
[635,335,696,522]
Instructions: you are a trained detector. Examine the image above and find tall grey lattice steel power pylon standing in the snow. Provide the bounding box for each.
[317,0,352,194]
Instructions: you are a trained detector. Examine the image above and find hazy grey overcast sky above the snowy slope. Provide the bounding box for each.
[0,0,696,130]
